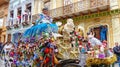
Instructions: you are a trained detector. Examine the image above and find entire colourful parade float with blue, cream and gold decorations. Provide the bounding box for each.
[3,9,116,67]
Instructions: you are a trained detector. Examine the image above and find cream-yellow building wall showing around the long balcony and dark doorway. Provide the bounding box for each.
[34,0,120,47]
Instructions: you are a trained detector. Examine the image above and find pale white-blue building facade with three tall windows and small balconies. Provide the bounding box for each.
[6,0,34,41]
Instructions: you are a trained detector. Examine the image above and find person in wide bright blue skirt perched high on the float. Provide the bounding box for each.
[23,8,58,38]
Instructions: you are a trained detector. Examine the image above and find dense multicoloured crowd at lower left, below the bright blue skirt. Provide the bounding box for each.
[1,37,58,67]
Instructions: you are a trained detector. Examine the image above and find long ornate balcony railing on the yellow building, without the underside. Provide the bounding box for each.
[50,0,110,18]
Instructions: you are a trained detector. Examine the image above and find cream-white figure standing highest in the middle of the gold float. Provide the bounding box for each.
[63,19,75,34]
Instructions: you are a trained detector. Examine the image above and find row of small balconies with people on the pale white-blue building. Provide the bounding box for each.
[6,13,32,30]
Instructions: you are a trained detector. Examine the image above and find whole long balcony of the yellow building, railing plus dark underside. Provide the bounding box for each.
[50,0,110,19]
